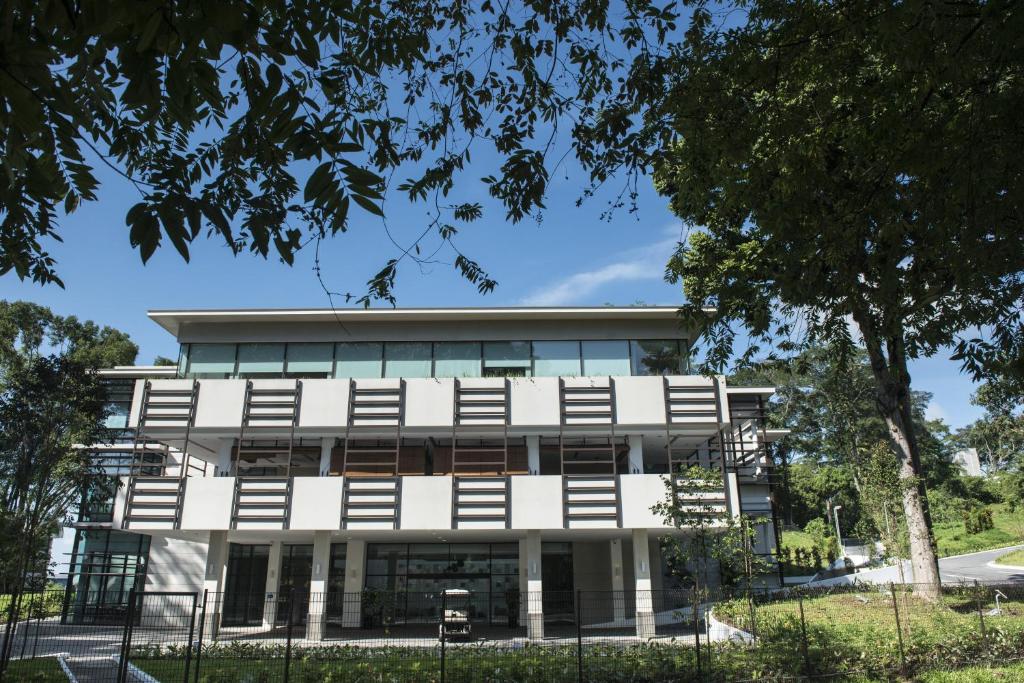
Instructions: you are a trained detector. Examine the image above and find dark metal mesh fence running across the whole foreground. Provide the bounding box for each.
[0,584,1024,683]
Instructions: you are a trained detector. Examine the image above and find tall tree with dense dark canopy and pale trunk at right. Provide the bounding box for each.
[647,0,1024,598]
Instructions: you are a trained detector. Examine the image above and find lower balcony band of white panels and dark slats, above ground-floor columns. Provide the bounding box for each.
[114,474,688,532]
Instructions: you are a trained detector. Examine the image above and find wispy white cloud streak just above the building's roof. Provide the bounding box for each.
[519,225,679,306]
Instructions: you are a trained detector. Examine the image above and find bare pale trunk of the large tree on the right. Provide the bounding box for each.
[861,326,941,600]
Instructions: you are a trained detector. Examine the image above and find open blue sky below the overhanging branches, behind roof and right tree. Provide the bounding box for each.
[0,151,980,427]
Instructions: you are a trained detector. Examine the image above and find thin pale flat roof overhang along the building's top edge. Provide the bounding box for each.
[148,306,711,337]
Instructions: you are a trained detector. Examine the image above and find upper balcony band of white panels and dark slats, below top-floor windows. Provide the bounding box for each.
[130,376,727,438]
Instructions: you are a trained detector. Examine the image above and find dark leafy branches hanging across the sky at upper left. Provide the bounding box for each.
[0,0,676,304]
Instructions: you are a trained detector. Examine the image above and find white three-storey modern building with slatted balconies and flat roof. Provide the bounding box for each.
[86,307,778,640]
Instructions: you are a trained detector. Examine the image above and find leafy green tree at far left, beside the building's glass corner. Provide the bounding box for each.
[0,302,137,592]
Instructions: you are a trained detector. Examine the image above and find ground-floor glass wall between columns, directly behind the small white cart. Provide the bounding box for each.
[364,543,519,624]
